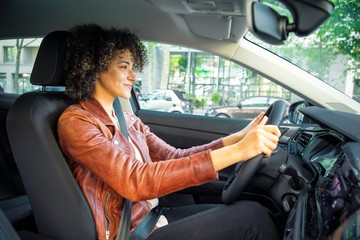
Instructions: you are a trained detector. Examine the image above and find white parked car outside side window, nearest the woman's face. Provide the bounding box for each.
[140,89,192,113]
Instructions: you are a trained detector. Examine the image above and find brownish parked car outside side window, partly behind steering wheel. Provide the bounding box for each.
[205,96,290,119]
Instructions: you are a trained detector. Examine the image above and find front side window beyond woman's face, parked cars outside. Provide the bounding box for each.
[137,42,300,118]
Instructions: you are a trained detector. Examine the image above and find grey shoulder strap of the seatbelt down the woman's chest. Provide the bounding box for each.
[113,97,131,240]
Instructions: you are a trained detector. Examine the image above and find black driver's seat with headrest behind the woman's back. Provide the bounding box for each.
[6,31,97,240]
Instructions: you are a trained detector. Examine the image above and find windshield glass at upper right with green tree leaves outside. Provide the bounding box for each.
[246,0,360,102]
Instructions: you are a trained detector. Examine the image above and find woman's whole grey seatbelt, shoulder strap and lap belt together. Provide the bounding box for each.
[113,97,163,240]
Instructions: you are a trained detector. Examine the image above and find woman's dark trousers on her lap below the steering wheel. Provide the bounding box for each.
[148,201,280,240]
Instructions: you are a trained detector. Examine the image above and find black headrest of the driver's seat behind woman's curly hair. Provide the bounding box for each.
[30,31,69,86]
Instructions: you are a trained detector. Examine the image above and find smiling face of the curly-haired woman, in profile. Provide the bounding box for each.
[95,50,136,99]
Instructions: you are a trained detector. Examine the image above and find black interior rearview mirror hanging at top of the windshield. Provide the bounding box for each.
[246,0,334,45]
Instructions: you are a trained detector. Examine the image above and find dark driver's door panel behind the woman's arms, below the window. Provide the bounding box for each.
[136,109,249,206]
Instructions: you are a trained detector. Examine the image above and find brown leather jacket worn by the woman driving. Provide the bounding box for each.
[58,100,223,239]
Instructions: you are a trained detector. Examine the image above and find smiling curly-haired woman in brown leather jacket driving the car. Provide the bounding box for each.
[58,24,280,239]
